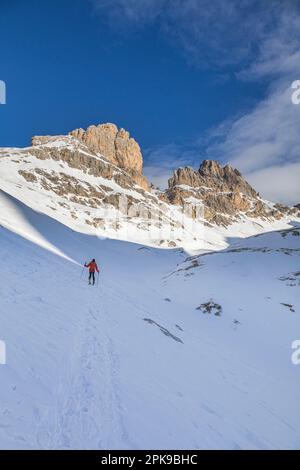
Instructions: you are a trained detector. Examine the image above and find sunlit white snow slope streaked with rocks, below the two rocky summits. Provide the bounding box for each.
[0,135,300,252]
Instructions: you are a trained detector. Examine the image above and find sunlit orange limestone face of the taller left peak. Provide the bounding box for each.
[69,123,148,189]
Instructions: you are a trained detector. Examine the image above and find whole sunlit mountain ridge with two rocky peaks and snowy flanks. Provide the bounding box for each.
[0,124,300,250]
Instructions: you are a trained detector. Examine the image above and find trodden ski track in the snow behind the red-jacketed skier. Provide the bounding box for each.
[37,280,127,449]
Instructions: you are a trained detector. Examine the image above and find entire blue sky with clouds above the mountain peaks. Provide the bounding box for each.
[0,0,300,203]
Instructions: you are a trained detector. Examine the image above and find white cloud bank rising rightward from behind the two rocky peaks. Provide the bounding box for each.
[145,77,300,204]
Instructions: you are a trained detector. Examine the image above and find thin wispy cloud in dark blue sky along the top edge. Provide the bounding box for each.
[89,0,284,69]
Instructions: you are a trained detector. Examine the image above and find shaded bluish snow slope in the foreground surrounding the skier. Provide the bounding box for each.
[0,190,300,449]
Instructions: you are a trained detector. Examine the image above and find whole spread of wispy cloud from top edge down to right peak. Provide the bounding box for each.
[91,0,300,203]
